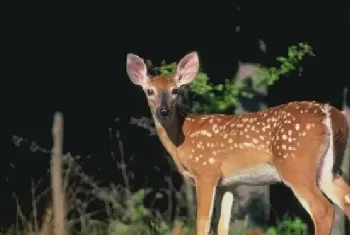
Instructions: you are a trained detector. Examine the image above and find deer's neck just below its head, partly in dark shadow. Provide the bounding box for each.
[153,106,186,155]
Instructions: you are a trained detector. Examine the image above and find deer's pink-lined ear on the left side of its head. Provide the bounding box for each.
[126,53,148,86]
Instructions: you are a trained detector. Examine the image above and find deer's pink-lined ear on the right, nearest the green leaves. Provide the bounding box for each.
[174,51,199,86]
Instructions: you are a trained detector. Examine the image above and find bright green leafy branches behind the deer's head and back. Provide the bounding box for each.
[154,42,314,113]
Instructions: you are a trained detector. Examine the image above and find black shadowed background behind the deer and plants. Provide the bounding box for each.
[0,1,350,231]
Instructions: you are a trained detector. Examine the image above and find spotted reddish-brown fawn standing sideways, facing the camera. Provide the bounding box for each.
[126,51,350,235]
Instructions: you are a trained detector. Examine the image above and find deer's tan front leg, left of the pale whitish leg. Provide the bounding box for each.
[195,176,219,235]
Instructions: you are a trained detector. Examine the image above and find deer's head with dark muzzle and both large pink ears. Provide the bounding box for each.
[126,52,199,125]
